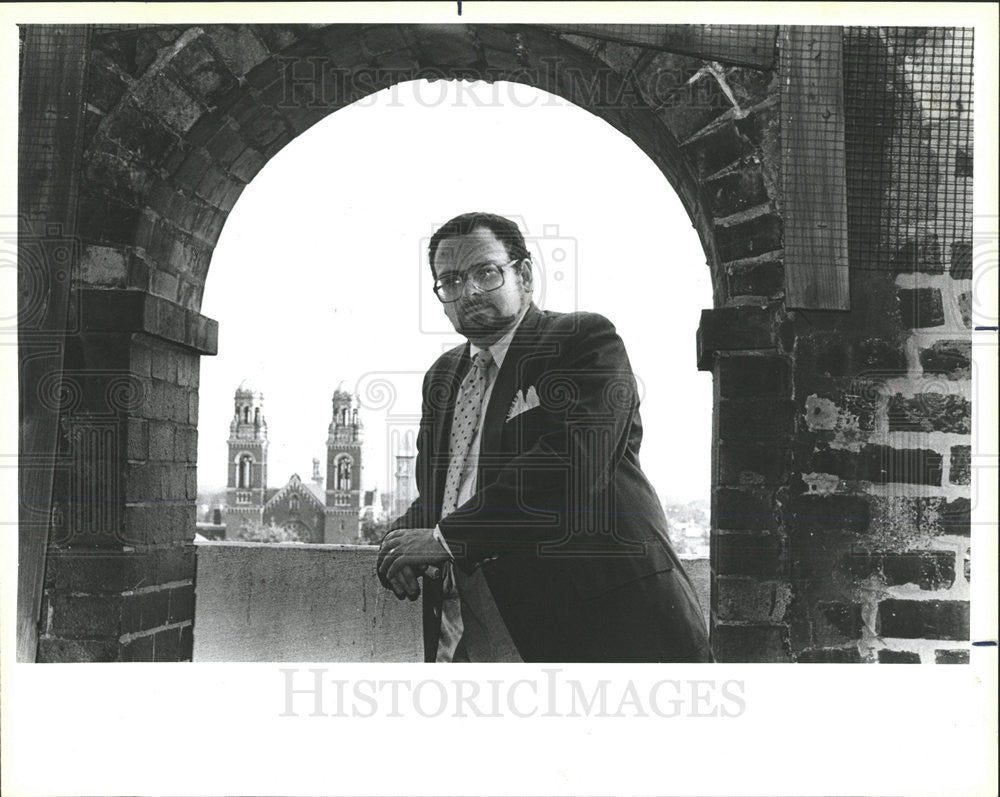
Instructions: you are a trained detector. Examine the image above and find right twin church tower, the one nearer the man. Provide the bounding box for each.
[324,383,364,543]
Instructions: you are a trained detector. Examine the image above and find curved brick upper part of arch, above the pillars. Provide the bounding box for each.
[79,25,782,311]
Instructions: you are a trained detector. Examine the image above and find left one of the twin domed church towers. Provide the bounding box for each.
[225,379,267,539]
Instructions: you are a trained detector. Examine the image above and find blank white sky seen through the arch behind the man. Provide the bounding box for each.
[198,81,712,501]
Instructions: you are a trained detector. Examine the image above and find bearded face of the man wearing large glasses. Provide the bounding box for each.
[434,227,531,347]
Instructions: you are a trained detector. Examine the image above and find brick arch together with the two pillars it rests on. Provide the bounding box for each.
[40,25,791,660]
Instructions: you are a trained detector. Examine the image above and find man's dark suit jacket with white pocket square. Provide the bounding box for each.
[390,304,710,661]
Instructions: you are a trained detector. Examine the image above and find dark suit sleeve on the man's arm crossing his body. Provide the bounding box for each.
[438,314,638,571]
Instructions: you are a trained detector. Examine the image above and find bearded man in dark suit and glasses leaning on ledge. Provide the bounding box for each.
[378,213,712,662]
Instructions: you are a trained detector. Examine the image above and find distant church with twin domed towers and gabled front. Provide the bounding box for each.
[223,380,364,543]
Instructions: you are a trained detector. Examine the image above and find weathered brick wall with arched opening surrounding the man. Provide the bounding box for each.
[27,25,972,661]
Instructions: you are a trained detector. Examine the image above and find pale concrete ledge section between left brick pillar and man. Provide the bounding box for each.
[194,542,423,662]
